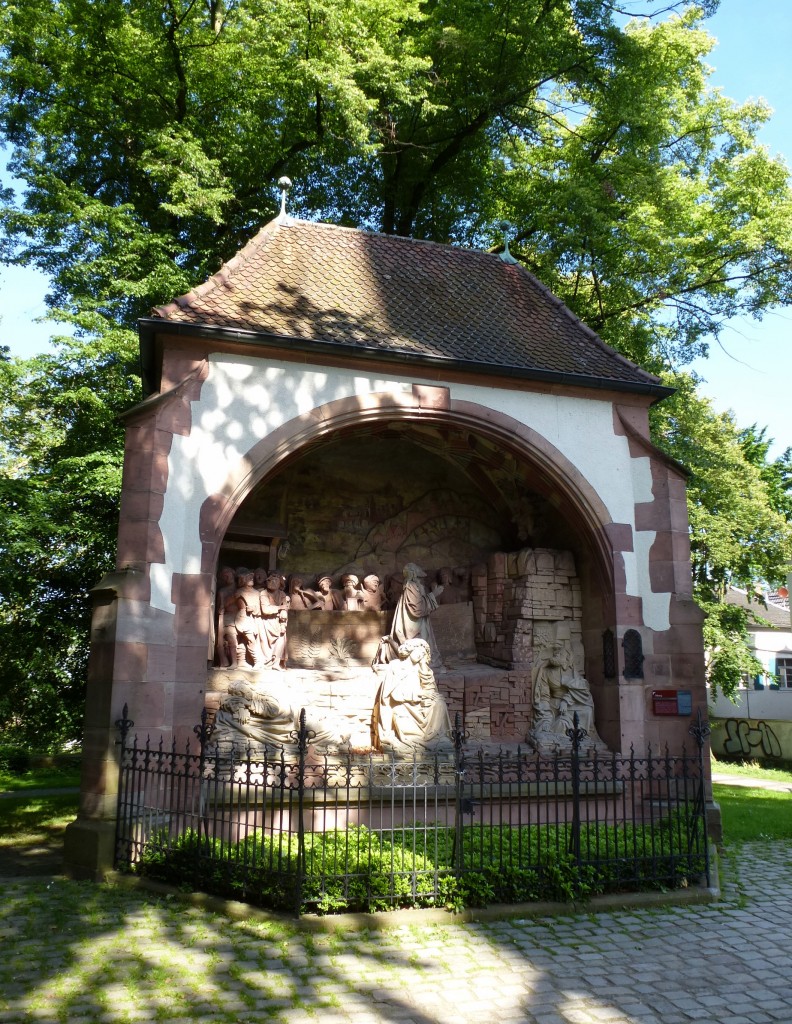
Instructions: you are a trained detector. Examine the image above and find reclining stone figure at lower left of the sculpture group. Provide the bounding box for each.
[211,677,350,757]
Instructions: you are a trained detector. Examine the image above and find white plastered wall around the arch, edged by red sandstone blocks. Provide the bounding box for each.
[151,353,671,630]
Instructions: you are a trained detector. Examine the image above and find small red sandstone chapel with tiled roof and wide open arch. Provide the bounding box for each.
[67,203,706,877]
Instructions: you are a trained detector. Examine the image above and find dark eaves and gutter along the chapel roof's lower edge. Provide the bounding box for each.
[137,316,675,399]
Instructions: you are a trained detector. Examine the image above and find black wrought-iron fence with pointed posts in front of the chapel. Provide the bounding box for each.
[116,708,710,913]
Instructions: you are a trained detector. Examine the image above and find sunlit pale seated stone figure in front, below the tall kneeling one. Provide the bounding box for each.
[372,637,452,753]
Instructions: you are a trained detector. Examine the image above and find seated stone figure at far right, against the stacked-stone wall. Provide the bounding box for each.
[530,623,603,750]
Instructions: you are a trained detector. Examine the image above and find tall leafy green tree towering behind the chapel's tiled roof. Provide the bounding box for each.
[0,0,792,737]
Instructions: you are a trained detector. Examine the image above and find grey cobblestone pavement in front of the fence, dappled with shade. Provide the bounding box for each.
[0,841,792,1024]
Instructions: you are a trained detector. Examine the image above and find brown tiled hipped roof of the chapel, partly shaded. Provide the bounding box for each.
[152,217,658,390]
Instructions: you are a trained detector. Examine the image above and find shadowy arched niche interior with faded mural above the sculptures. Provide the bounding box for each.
[203,395,618,739]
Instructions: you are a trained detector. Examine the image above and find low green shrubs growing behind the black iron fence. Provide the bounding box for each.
[136,812,704,913]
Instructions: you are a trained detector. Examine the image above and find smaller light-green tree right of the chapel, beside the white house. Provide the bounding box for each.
[653,375,792,696]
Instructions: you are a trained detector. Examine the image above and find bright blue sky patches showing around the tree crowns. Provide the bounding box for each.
[0,0,792,455]
